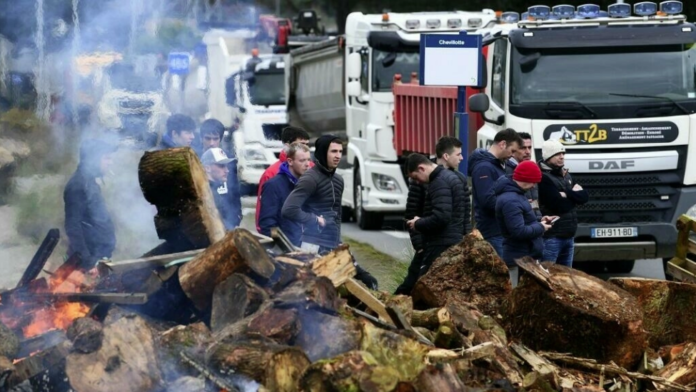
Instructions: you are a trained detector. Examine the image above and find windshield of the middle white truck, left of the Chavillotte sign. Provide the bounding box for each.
[372,49,420,92]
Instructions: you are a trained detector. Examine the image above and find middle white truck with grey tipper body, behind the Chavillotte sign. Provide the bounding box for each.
[286,10,497,229]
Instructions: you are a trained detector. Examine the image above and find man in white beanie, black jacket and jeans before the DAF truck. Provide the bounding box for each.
[539,140,589,267]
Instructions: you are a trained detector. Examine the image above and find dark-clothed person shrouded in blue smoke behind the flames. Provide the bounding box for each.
[63,140,116,269]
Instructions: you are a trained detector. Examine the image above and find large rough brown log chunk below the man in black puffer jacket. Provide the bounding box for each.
[411,234,512,316]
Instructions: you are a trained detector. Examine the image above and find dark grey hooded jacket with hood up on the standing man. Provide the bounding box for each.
[283,135,343,249]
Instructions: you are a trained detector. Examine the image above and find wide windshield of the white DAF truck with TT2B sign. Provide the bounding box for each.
[510,44,696,117]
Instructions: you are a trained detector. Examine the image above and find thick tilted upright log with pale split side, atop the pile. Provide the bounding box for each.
[138,147,225,248]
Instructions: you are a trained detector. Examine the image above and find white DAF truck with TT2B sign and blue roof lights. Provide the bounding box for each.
[469,1,696,272]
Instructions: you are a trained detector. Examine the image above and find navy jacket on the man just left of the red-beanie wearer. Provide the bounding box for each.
[468,148,505,239]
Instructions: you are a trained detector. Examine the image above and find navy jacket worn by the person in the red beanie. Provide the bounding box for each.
[494,176,544,266]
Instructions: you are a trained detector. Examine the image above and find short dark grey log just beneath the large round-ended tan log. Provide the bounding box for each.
[210,274,269,331]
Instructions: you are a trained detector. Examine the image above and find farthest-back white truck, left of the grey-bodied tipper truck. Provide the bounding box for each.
[204,31,288,193]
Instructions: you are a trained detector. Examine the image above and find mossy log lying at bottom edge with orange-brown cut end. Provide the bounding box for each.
[206,339,310,391]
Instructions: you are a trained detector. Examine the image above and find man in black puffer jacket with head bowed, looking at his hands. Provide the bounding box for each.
[407,154,466,276]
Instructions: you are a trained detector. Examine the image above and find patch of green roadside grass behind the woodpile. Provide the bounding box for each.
[343,237,408,293]
